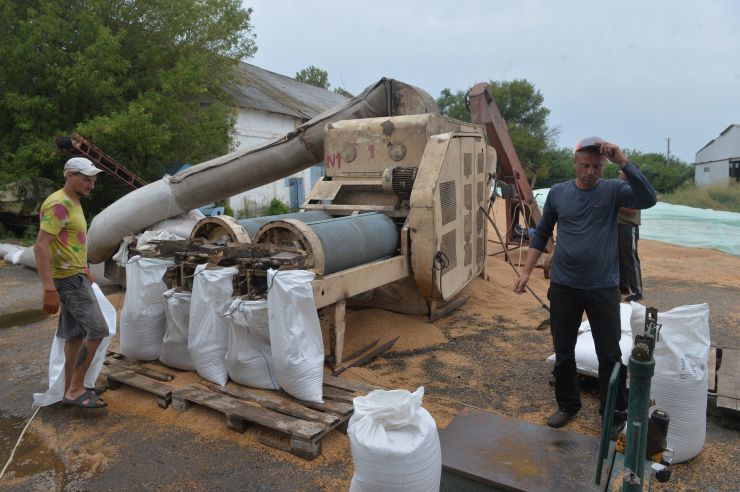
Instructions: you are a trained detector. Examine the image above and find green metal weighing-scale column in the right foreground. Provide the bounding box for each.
[594,308,673,492]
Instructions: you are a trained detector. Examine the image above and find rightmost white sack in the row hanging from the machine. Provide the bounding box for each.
[267,270,324,403]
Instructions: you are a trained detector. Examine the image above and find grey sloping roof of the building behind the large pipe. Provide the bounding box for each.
[226,62,347,120]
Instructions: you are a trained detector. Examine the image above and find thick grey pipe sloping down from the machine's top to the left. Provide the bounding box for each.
[88,78,439,263]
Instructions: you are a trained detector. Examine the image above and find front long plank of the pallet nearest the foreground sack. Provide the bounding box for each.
[172,386,327,441]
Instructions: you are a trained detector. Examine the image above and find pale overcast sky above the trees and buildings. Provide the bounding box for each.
[245,0,740,162]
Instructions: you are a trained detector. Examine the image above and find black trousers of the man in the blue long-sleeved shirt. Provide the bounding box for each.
[547,283,627,415]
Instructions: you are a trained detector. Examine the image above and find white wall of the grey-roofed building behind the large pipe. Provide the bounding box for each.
[229,108,315,213]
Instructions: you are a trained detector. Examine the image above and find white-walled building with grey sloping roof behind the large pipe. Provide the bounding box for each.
[226,63,347,212]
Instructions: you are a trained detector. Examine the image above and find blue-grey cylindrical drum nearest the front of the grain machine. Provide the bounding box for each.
[254,212,399,275]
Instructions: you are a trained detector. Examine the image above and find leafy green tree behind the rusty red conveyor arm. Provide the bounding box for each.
[437,79,557,179]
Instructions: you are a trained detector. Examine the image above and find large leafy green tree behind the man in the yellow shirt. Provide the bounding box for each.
[0,0,256,211]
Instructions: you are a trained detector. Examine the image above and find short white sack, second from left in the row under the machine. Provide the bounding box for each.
[159,289,195,371]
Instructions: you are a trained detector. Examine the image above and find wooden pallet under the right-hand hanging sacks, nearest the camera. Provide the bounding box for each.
[172,375,373,460]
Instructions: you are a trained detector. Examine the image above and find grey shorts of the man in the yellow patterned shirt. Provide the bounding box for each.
[54,273,108,340]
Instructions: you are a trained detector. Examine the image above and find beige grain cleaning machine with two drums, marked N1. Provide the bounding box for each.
[160,114,496,365]
